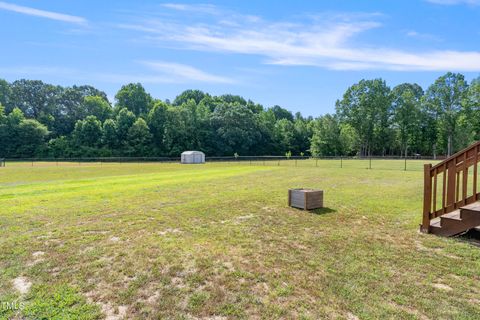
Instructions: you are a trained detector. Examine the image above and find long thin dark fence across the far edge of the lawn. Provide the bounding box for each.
[0,156,437,171]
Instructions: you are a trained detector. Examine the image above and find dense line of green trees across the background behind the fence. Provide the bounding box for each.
[0,73,480,158]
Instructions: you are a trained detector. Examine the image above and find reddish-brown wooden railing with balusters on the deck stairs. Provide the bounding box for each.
[421,141,480,233]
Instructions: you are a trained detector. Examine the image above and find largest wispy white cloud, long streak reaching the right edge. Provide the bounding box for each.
[119,5,480,71]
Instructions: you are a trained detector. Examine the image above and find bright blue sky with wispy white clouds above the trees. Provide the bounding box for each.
[0,0,480,116]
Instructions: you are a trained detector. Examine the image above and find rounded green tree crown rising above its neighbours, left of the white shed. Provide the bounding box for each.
[115,83,153,116]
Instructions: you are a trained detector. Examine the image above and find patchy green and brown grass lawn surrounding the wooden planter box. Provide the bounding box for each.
[0,160,480,319]
